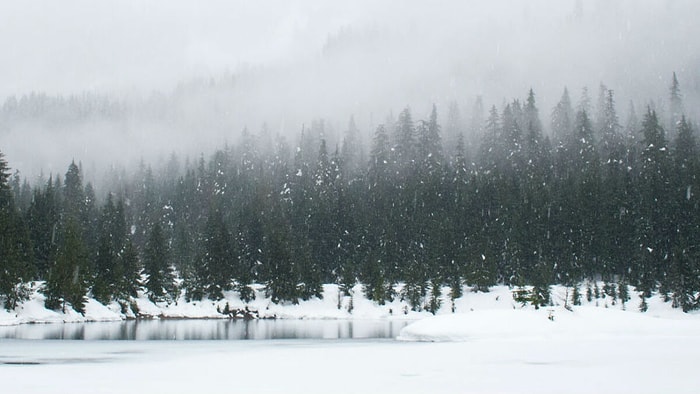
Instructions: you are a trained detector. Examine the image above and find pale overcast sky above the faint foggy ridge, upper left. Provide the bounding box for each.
[0,0,426,96]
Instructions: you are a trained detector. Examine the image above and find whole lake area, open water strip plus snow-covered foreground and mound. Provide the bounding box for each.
[0,308,700,394]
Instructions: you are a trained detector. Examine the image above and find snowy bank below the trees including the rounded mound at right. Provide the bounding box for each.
[0,283,700,328]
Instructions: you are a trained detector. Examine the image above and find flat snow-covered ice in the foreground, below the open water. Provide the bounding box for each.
[0,333,700,394]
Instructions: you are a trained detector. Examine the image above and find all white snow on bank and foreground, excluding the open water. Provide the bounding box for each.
[0,286,700,394]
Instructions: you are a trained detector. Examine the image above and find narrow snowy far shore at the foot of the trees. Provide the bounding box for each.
[0,284,700,325]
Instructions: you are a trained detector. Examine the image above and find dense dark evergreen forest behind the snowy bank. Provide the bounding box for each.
[0,75,700,311]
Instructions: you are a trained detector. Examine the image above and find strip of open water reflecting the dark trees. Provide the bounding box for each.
[0,319,409,341]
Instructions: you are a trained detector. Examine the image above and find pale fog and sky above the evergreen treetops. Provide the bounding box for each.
[0,0,700,185]
